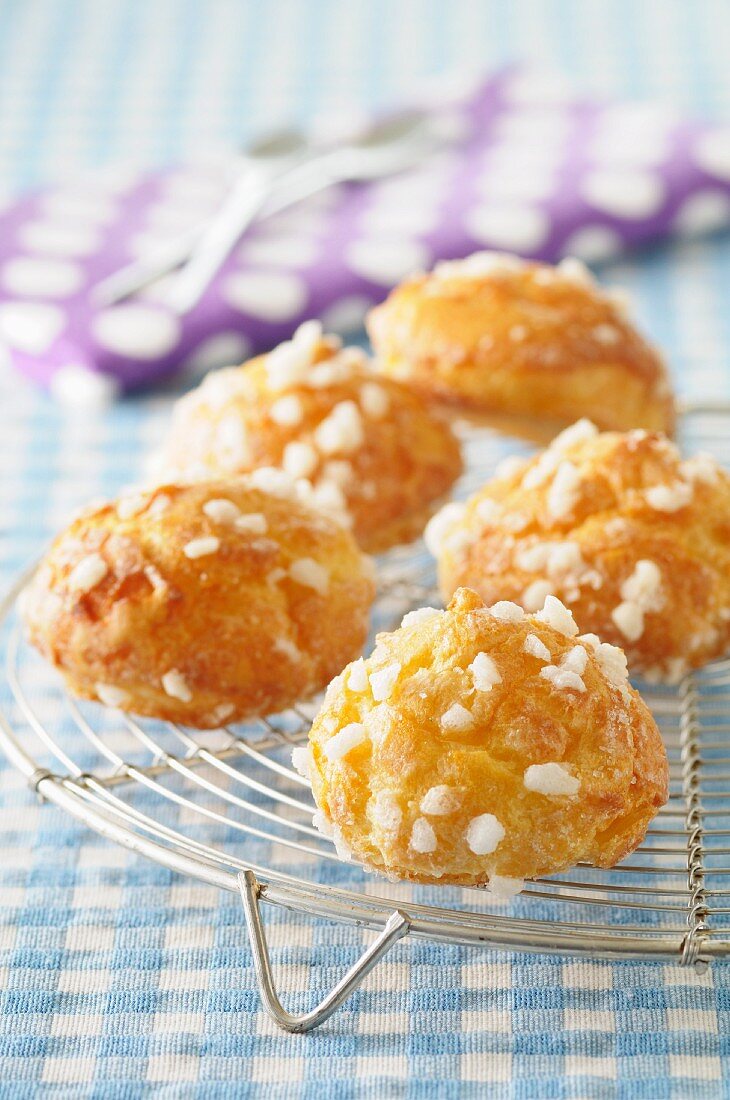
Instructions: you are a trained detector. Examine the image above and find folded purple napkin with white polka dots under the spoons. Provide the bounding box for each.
[0,67,730,395]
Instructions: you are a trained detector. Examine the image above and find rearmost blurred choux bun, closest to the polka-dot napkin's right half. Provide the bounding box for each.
[367,252,674,433]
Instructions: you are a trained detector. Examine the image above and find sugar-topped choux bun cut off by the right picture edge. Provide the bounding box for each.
[427,420,730,682]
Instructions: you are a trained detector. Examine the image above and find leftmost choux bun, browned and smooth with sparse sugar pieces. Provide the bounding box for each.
[22,471,375,728]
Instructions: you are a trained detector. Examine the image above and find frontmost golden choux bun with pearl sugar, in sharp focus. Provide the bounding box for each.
[294,589,667,894]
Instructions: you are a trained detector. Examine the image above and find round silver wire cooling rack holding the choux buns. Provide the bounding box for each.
[0,405,730,1031]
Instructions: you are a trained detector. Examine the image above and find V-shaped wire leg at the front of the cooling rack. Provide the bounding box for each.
[237,871,410,1032]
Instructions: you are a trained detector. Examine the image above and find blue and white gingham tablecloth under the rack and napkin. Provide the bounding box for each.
[0,0,730,1100]
